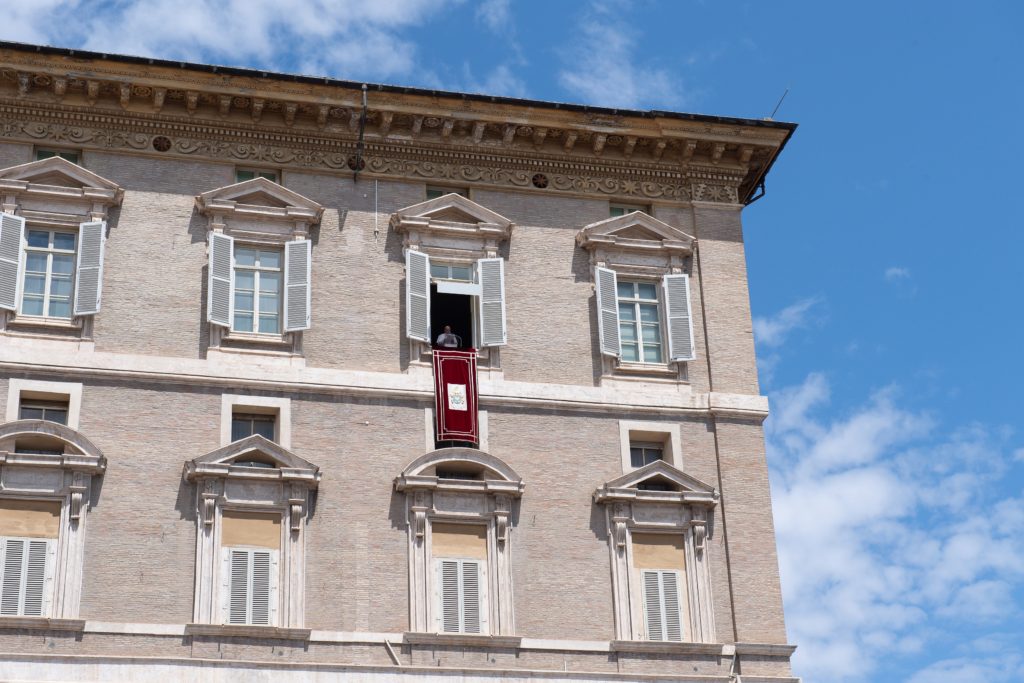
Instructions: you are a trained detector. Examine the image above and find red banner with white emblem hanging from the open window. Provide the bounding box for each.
[434,348,479,443]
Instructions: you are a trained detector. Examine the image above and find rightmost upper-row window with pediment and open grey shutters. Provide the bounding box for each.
[577,211,695,380]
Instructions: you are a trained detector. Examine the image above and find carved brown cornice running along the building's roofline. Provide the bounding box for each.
[0,47,791,204]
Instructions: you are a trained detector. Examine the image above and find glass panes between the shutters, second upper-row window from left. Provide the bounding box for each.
[231,245,282,335]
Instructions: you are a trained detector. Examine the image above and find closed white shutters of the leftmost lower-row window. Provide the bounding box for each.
[0,537,56,616]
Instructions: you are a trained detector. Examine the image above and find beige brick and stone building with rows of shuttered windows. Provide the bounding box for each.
[0,43,797,683]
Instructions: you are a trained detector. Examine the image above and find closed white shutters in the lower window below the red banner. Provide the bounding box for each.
[437,559,487,634]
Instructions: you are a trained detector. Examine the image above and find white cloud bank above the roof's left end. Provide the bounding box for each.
[0,0,459,80]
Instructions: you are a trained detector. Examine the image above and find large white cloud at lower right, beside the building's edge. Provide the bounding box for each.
[766,374,1024,683]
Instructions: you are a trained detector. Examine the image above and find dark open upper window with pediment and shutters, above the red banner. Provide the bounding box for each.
[391,193,512,368]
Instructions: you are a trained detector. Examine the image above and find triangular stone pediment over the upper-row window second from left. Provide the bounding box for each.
[196,177,324,223]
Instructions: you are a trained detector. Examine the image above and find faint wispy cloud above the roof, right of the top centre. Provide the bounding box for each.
[558,2,685,109]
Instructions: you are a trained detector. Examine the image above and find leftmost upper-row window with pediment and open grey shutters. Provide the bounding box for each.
[0,155,123,338]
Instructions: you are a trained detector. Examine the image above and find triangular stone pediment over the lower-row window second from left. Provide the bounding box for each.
[184,434,321,486]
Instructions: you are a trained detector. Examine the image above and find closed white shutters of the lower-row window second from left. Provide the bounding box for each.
[221,548,278,626]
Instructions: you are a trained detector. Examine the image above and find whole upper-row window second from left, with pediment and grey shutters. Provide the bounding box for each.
[196,172,324,356]
